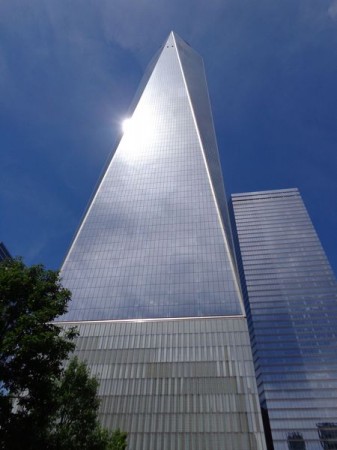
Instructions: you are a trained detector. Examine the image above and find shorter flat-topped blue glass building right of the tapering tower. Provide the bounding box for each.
[232,189,337,450]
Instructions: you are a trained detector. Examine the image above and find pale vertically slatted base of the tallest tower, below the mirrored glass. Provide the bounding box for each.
[64,317,264,450]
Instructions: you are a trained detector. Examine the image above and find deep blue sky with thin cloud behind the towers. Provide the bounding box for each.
[0,0,337,273]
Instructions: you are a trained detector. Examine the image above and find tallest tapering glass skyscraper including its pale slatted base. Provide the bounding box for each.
[57,33,265,450]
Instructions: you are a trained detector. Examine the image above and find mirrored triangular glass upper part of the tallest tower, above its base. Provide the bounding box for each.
[61,33,243,320]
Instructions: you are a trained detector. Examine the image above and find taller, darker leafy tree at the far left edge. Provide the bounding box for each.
[0,259,76,449]
